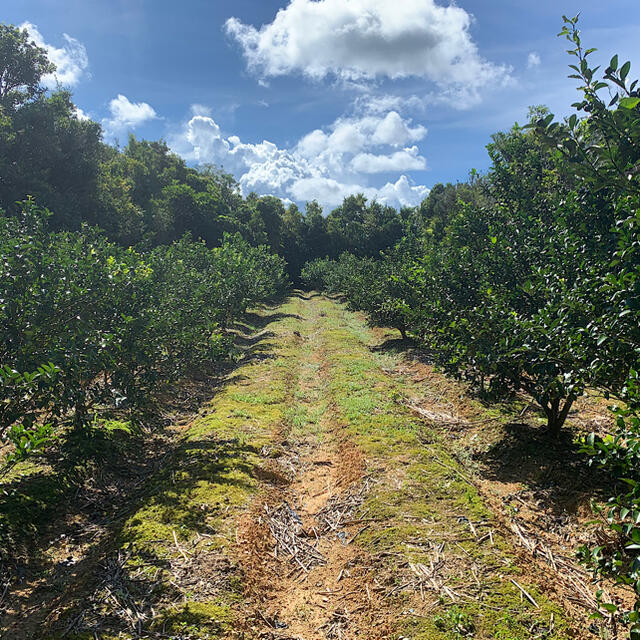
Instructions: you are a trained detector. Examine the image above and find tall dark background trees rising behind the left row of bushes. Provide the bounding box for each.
[0,24,410,281]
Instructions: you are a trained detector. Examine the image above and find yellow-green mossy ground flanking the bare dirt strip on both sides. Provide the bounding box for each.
[2,295,573,640]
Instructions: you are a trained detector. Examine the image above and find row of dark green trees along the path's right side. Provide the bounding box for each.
[303,18,640,624]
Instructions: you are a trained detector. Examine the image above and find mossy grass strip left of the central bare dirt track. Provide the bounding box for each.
[100,307,308,638]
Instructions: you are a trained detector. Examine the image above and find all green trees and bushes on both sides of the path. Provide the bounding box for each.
[0,18,640,634]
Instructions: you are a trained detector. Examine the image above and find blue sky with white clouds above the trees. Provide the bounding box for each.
[5,0,640,209]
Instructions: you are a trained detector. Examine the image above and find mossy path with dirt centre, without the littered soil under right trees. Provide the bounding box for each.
[2,294,604,640]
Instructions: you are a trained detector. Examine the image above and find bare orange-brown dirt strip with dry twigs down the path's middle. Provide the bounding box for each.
[237,299,391,640]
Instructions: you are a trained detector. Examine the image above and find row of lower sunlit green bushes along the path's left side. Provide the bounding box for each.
[0,201,287,476]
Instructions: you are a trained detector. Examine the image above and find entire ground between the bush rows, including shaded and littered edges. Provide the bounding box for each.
[0,292,624,640]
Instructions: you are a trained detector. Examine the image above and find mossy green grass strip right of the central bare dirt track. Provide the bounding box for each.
[314,299,571,640]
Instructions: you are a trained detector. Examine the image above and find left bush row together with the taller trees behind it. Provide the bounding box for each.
[0,24,410,471]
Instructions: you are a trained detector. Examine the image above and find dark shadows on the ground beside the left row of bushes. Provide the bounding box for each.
[0,322,282,640]
